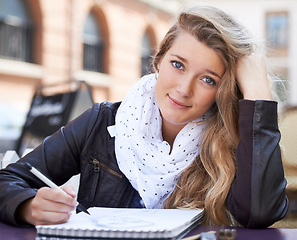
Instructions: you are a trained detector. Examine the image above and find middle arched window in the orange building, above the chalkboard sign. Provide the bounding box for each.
[83,13,104,72]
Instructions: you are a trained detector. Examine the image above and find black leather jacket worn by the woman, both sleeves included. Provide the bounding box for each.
[0,100,288,227]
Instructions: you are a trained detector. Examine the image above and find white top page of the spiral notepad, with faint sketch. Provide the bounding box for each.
[37,208,203,232]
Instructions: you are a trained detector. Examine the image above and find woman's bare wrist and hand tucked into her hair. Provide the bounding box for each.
[237,54,272,100]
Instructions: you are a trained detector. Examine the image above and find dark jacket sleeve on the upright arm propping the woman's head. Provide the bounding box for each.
[227,100,288,228]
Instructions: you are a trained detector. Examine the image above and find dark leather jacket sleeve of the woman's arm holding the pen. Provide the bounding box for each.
[0,104,99,225]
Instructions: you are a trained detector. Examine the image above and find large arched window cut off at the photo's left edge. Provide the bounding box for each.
[0,0,33,62]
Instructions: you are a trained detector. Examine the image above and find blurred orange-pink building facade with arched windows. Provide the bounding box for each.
[0,0,176,112]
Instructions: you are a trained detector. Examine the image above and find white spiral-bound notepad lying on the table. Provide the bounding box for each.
[36,207,203,239]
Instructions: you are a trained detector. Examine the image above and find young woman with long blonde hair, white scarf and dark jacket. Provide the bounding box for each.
[0,6,288,227]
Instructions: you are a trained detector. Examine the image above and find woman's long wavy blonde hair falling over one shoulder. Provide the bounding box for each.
[153,6,254,225]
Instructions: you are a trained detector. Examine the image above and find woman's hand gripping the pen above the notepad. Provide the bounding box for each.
[18,185,77,225]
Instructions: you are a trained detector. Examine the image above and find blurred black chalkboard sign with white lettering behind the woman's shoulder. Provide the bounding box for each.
[16,81,94,155]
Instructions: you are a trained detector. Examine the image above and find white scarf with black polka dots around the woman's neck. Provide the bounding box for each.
[115,74,203,208]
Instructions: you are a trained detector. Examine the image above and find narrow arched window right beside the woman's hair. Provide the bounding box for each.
[141,32,153,76]
